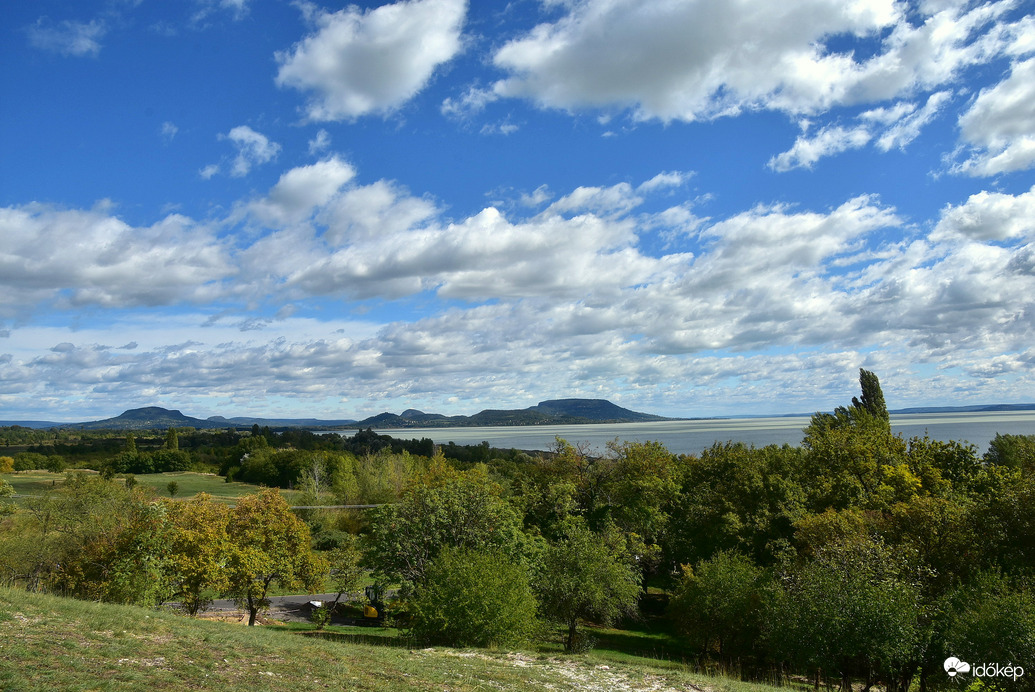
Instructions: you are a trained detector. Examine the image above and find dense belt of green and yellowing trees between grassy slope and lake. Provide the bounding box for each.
[0,370,1035,691]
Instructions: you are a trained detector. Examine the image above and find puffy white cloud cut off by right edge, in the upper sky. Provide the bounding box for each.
[954,58,1035,176]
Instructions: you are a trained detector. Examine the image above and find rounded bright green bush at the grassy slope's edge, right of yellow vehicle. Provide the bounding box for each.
[411,547,536,646]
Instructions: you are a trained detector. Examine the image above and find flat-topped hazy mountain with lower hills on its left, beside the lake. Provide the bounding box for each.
[350,399,673,428]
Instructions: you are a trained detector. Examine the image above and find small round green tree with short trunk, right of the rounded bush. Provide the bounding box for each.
[536,520,640,652]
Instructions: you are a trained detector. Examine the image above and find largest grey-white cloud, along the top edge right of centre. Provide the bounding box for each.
[494,0,1026,121]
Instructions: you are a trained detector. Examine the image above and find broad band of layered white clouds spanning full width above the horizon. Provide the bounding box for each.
[8,162,1035,413]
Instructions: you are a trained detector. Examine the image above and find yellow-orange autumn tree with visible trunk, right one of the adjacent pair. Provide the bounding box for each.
[224,489,327,625]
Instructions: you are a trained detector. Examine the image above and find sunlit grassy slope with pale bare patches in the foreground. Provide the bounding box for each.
[0,588,790,692]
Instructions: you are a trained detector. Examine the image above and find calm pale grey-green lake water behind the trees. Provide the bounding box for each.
[343,411,1035,454]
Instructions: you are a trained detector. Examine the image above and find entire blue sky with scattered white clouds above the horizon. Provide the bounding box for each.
[0,0,1035,421]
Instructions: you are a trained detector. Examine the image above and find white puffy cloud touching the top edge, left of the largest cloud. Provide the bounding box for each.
[276,0,467,121]
